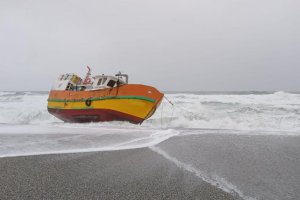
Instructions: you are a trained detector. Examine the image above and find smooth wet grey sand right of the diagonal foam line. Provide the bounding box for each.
[154,130,300,200]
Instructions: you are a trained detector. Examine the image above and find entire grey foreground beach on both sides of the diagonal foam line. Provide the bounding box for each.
[0,133,300,200]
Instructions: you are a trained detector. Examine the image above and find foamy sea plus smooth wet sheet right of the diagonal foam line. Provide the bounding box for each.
[0,91,300,199]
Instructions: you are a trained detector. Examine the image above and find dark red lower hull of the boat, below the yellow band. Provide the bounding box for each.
[48,108,144,124]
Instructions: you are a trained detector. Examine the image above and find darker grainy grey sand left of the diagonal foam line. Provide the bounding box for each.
[0,148,238,200]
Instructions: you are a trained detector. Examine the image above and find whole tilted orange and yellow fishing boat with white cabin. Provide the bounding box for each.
[47,67,164,124]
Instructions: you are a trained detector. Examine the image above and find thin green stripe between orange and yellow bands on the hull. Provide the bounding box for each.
[48,96,155,103]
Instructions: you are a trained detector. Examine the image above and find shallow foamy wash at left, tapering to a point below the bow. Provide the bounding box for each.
[0,124,178,157]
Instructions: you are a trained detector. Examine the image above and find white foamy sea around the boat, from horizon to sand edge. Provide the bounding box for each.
[0,92,300,157]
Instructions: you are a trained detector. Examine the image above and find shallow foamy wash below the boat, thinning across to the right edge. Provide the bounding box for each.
[0,122,299,157]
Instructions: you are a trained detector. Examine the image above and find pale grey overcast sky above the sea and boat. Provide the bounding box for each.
[0,0,300,91]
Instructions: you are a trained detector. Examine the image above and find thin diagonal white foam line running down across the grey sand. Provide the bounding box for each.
[150,146,255,200]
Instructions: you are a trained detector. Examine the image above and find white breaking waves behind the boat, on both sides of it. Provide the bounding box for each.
[0,92,300,131]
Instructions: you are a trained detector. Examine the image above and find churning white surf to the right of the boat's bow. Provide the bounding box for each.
[145,92,300,132]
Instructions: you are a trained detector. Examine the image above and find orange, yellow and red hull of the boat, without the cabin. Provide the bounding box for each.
[48,84,163,124]
